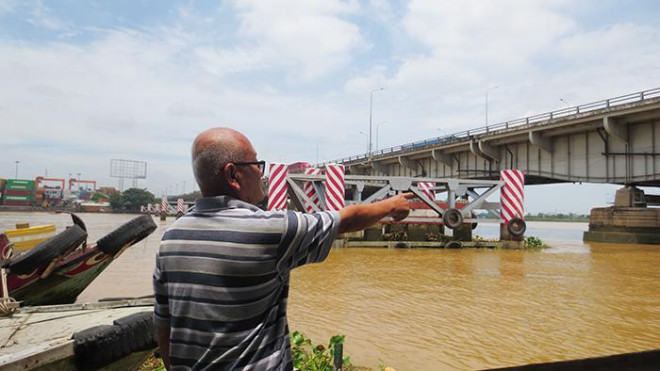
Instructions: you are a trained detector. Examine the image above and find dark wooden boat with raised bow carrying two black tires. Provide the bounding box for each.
[0,214,156,305]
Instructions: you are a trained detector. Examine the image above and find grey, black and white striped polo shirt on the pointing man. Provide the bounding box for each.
[153,196,339,370]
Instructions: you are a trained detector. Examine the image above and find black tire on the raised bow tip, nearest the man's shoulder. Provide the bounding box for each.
[96,215,157,255]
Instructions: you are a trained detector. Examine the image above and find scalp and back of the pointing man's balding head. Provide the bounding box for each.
[192,128,254,197]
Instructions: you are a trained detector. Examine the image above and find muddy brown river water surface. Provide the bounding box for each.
[0,212,660,370]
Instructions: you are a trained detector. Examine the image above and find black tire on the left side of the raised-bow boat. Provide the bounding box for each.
[7,225,87,274]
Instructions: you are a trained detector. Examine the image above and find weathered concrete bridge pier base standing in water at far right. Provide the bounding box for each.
[583,186,660,245]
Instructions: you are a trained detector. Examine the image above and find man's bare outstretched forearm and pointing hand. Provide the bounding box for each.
[339,193,415,233]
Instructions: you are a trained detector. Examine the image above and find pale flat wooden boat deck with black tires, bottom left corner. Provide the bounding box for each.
[0,298,156,371]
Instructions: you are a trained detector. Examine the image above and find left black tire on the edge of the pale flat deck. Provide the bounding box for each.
[72,325,124,370]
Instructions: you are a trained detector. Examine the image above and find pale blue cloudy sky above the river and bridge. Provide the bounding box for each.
[0,0,660,213]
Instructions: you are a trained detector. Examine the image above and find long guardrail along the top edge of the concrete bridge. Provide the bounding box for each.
[318,88,660,166]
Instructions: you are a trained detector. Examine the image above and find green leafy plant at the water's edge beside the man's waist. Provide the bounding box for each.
[291,331,352,371]
